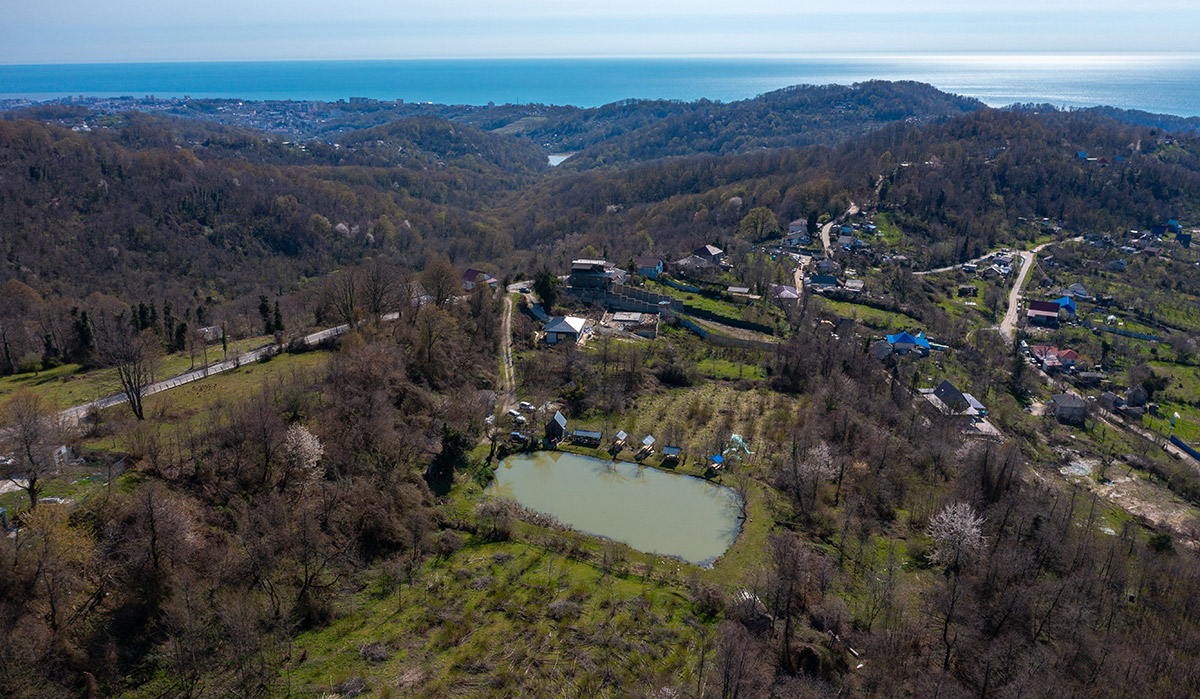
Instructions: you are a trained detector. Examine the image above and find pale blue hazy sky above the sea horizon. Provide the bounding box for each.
[0,0,1200,65]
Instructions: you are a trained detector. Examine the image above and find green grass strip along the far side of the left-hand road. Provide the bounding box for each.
[0,335,271,410]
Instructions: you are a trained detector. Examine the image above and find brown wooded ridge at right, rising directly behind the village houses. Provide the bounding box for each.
[487,109,1200,267]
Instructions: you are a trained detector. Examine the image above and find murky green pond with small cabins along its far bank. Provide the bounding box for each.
[487,452,742,566]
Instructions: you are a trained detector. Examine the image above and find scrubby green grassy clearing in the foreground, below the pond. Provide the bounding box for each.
[286,536,712,697]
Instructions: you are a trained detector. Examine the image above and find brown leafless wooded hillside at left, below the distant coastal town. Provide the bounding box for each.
[0,118,530,298]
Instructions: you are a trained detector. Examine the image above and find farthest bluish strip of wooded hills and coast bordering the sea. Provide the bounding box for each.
[24,82,983,169]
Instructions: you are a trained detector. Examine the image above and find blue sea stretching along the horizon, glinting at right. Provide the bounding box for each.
[0,54,1200,117]
